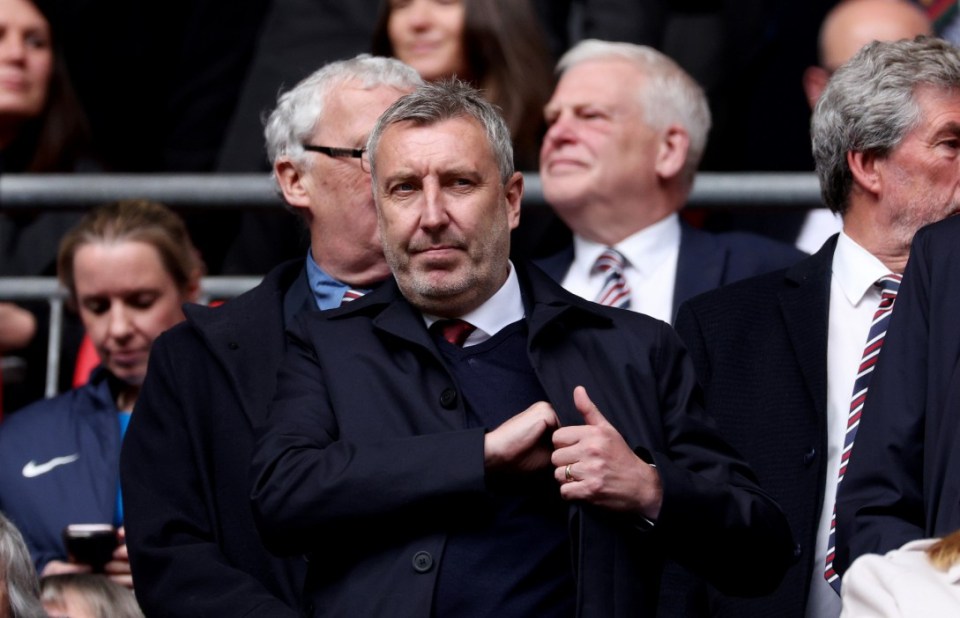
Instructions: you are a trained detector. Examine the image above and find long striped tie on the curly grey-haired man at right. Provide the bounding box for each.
[824,274,901,594]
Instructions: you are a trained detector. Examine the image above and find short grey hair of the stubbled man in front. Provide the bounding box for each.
[367,78,514,184]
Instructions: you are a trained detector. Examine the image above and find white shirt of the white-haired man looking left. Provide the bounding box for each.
[563,214,680,322]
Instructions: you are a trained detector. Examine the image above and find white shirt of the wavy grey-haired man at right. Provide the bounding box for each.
[806,232,890,618]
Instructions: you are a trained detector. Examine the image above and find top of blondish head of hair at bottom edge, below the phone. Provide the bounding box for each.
[40,573,143,618]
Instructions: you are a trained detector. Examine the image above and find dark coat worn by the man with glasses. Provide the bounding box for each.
[121,259,309,618]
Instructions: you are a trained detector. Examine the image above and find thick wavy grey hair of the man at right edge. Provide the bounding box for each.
[810,36,960,215]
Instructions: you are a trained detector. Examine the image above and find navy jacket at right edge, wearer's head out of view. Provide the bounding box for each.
[835,217,960,573]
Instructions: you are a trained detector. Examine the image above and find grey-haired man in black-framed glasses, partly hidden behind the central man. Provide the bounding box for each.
[121,55,421,617]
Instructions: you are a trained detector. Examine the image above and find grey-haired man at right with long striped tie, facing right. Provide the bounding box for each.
[664,37,960,618]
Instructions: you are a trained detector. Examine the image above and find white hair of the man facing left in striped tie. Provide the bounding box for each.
[557,39,710,183]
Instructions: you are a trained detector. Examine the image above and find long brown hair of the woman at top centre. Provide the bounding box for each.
[373,0,554,170]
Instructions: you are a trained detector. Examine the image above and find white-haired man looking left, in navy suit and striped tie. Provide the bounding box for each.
[537,40,803,322]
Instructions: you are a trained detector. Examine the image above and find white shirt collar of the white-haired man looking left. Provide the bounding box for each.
[571,213,680,276]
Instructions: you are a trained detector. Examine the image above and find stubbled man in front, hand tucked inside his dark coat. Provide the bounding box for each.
[252,82,792,618]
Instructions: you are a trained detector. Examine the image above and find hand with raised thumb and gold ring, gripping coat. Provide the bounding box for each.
[551,386,663,520]
